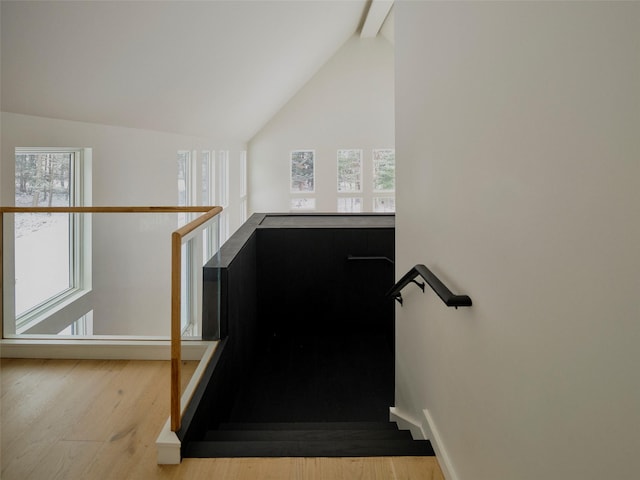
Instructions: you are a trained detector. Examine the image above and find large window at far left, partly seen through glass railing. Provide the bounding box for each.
[14,148,91,334]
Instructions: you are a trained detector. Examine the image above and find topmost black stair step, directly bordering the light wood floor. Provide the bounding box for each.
[183,440,435,458]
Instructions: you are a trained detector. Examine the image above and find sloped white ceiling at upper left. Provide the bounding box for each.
[1,0,380,141]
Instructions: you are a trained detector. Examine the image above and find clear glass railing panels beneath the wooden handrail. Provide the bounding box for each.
[2,212,219,340]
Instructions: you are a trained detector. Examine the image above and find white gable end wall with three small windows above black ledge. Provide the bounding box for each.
[249,36,395,213]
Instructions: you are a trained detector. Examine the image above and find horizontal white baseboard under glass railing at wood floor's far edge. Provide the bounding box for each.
[0,339,211,360]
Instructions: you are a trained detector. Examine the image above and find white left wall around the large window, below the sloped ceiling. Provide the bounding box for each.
[1,112,244,336]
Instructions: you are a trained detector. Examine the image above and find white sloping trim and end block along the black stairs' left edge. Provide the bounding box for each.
[156,342,218,465]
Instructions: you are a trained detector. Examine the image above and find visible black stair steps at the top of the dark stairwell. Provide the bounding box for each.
[184,422,434,458]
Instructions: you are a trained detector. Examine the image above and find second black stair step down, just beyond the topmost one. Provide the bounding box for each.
[204,429,412,442]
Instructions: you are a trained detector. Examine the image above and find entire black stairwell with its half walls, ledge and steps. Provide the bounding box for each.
[179,214,434,458]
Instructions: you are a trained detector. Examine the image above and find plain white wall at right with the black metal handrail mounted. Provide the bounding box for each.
[395,2,640,480]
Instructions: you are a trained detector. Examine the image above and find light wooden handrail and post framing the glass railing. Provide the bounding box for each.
[0,206,222,432]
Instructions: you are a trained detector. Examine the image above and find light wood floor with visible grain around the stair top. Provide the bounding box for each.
[0,359,444,480]
